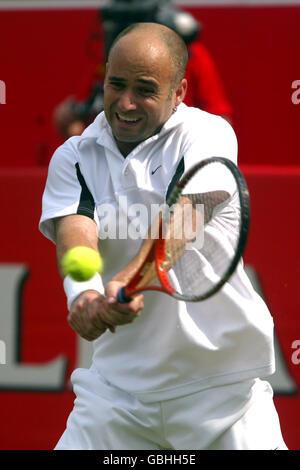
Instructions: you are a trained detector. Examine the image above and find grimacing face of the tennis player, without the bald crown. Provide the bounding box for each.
[104,34,183,156]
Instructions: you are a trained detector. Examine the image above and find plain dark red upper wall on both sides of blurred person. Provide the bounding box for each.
[0,6,300,167]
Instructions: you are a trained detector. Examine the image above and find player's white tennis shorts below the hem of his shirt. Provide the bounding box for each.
[55,369,287,450]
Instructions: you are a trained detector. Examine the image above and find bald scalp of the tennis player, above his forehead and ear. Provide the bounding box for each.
[108,23,188,88]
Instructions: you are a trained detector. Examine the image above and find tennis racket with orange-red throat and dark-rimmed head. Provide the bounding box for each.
[118,157,250,303]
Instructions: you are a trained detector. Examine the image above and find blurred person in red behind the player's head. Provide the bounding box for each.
[54,0,232,139]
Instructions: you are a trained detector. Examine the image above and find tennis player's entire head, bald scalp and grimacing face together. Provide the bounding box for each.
[104,23,187,156]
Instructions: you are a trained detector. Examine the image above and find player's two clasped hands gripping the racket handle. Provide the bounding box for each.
[68,281,144,341]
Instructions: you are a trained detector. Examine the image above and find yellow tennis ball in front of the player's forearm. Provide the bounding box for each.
[62,246,103,282]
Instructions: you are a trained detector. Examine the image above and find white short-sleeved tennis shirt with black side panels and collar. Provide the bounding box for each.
[40,104,274,401]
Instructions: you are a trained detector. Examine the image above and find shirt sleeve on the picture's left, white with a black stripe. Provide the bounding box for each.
[39,137,99,243]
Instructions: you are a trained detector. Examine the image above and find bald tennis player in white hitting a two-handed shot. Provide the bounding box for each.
[40,23,286,450]
